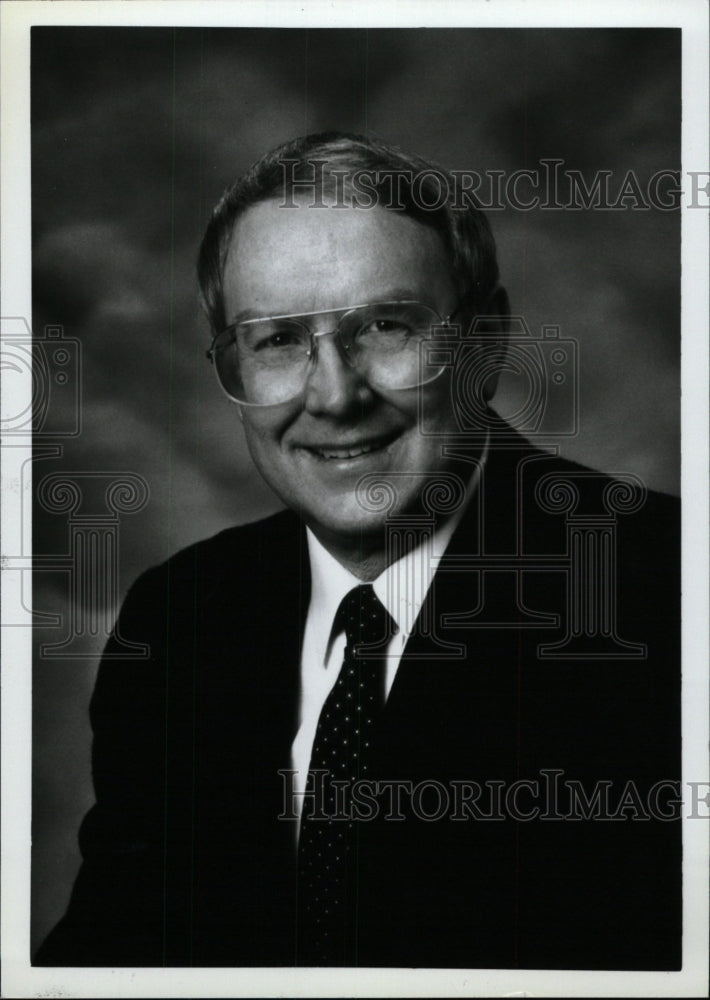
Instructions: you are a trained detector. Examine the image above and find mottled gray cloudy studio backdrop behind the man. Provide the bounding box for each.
[32,28,680,956]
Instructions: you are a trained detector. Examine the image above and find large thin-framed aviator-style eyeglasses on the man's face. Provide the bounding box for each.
[206,301,460,406]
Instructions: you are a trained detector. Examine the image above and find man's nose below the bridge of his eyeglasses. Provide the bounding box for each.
[304,334,372,418]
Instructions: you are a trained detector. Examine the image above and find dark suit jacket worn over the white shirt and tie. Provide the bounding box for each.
[35,434,681,969]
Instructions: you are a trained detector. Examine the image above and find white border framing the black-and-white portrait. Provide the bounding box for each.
[0,0,710,997]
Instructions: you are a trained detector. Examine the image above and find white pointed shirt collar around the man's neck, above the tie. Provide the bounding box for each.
[306,435,490,664]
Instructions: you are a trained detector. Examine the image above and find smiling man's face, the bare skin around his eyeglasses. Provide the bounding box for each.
[224,200,464,549]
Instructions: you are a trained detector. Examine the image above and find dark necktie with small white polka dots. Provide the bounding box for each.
[298,584,397,966]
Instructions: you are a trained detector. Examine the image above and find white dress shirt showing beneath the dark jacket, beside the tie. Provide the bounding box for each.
[291,442,488,826]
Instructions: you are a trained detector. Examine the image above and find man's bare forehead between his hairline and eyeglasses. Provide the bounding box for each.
[224,200,454,322]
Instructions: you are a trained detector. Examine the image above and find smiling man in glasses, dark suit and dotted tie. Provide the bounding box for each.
[36,134,680,969]
